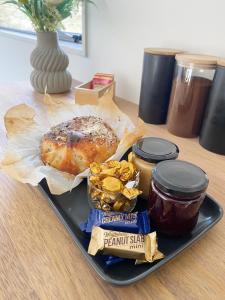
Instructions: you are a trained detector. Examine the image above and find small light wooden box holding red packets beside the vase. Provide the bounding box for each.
[75,81,116,105]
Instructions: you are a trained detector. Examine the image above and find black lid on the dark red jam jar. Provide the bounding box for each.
[152,160,209,197]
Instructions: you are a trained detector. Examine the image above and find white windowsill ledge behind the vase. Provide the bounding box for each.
[0,29,86,56]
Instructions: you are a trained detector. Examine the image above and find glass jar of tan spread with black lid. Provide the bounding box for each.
[132,137,179,200]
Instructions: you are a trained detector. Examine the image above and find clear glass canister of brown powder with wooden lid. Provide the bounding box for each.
[167,54,217,138]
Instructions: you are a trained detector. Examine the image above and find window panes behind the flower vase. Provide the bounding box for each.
[0,4,85,46]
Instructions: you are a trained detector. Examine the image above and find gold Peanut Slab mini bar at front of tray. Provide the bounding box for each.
[88,226,163,264]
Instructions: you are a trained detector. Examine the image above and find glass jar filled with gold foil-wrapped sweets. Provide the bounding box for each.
[88,160,142,212]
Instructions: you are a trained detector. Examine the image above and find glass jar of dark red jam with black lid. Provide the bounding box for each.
[148,160,209,236]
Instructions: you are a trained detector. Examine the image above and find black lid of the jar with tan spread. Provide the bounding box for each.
[132,137,179,163]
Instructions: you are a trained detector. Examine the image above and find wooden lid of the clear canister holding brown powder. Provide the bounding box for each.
[176,54,218,65]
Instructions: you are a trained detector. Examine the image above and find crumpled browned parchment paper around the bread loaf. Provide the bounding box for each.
[0,89,145,195]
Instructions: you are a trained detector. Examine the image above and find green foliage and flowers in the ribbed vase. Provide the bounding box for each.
[0,0,93,31]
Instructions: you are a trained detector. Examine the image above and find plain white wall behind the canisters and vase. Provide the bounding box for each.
[0,0,225,102]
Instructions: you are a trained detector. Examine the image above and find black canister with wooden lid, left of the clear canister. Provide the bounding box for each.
[139,48,181,124]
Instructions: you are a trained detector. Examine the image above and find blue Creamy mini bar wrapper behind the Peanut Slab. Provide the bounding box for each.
[80,209,150,234]
